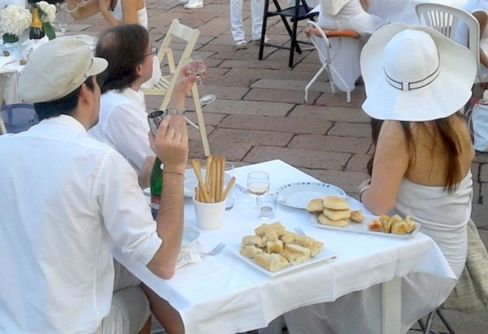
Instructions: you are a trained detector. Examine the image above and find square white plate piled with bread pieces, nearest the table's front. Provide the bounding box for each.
[230,222,336,277]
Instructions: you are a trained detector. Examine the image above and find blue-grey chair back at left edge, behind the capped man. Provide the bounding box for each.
[0,103,39,133]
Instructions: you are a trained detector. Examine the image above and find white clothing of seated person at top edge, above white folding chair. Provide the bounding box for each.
[314,0,384,34]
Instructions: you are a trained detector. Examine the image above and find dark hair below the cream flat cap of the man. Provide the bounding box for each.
[34,76,95,121]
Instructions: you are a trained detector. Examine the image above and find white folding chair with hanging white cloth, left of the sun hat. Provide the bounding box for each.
[305,21,361,103]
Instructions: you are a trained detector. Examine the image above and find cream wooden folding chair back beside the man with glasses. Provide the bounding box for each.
[152,19,200,109]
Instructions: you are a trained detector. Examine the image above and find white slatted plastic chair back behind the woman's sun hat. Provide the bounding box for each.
[415,3,480,79]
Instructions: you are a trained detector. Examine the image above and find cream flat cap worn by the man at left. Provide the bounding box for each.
[18,37,108,103]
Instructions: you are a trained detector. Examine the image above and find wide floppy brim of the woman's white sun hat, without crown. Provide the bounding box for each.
[361,23,477,122]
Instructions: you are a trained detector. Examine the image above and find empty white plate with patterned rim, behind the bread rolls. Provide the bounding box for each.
[278,182,347,209]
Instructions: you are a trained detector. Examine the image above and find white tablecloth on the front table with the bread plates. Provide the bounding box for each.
[116,160,454,334]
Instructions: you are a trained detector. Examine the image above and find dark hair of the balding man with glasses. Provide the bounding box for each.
[95,24,149,93]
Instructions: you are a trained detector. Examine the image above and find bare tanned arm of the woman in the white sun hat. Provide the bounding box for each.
[361,121,409,215]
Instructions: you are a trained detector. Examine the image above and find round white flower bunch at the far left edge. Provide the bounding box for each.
[0,5,32,43]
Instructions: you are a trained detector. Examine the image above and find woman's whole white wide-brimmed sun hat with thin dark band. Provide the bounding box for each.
[361,23,477,122]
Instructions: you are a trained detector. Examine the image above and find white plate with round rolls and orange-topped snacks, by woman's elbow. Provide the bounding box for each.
[307,196,420,239]
